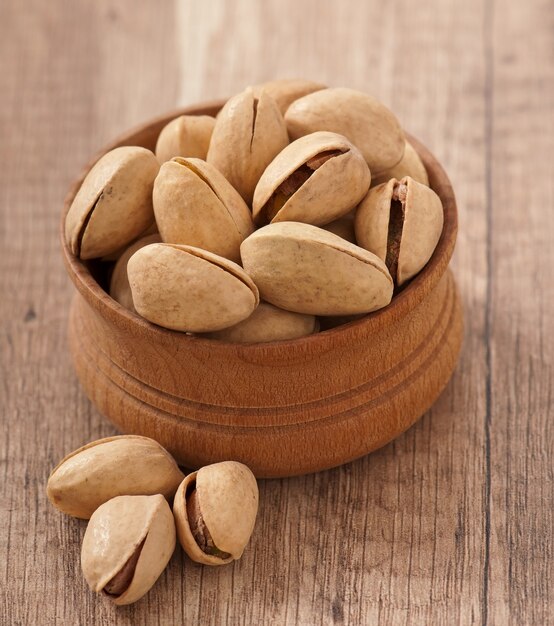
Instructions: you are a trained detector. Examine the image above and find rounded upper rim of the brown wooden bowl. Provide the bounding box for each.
[59,100,458,357]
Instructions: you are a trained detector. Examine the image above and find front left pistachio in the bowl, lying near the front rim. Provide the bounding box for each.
[127,243,259,332]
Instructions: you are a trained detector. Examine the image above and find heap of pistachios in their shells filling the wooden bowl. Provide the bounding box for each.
[65,80,443,343]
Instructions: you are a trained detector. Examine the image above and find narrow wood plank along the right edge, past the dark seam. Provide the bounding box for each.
[487,0,554,625]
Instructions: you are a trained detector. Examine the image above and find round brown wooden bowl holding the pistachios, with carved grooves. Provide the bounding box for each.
[61,102,462,477]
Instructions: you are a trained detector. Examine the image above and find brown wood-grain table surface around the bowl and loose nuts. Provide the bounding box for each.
[0,0,554,626]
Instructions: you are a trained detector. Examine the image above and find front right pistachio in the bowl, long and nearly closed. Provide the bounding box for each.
[241,222,393,315]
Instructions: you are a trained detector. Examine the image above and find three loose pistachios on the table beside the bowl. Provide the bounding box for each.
[47,435,258,604]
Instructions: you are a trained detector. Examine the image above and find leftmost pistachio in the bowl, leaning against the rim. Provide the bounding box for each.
[65,146,159,259]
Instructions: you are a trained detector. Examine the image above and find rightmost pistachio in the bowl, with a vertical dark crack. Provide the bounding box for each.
[354,176,444,285]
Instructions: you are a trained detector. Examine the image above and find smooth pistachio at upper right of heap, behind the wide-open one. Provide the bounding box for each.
[285,87,404,176]
